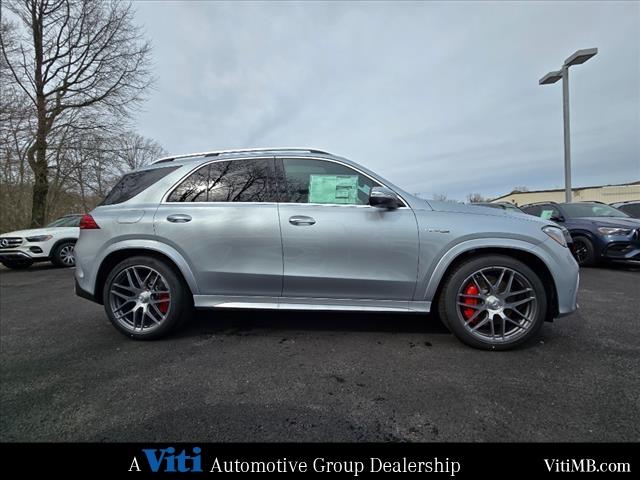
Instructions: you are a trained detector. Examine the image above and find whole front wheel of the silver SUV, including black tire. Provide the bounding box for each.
[438,255,547,350]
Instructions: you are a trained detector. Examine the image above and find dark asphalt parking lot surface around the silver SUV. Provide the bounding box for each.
[0,266,640,441]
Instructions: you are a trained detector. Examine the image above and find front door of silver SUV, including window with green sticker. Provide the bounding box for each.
[276,158,418,301]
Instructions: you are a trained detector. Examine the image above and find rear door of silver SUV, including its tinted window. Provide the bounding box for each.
[154,157,282,297]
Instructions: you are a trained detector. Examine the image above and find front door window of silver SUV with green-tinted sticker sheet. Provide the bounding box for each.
[280,158,380,205]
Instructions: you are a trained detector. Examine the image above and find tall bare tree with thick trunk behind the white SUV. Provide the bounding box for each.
[0,0,152,226]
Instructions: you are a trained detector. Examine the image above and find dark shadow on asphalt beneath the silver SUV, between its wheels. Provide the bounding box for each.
[177,310,449,337]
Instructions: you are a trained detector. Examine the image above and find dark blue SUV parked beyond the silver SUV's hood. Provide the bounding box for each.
[522,202,640,266]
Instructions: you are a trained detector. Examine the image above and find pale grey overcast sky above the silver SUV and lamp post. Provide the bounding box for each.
[136,1,640,199]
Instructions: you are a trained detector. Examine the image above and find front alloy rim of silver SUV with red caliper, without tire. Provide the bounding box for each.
[456,266,538,343]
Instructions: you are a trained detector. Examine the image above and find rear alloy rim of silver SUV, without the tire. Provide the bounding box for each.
[109,265,171,333]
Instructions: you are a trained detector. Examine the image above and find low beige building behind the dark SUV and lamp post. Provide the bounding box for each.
[491,181,640,205]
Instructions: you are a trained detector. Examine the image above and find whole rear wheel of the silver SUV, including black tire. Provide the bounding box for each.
[102,256,193,340]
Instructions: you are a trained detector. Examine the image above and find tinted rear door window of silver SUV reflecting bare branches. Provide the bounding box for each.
[167,159,276,202]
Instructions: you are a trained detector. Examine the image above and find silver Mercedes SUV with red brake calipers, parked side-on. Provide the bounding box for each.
[75,148,578,350]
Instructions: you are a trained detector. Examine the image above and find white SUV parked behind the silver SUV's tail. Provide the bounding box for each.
[0,214,82,269]
